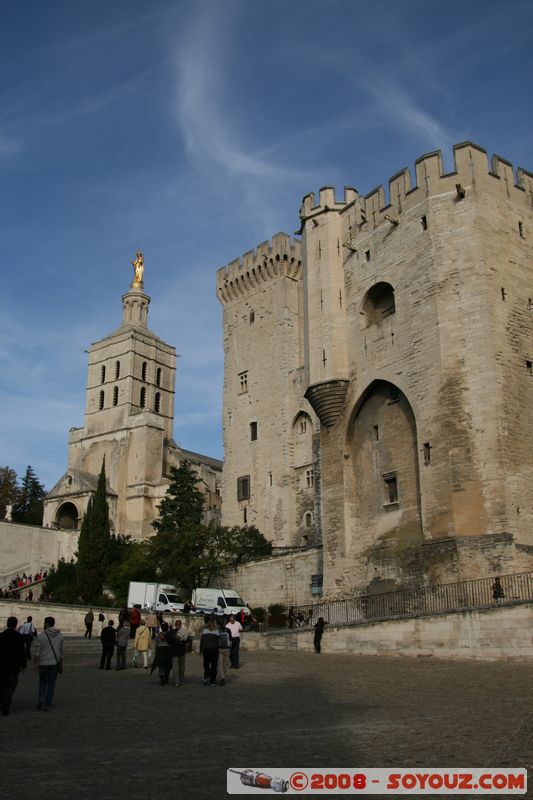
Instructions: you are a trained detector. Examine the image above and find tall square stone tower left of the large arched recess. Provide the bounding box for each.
[217,233,320,547]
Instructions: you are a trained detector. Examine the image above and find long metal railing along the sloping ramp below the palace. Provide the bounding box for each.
[260,572,533,629]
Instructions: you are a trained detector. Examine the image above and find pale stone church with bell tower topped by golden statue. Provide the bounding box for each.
[43,260,222,539]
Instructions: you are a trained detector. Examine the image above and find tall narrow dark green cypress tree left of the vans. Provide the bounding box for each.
[76,462,111,603]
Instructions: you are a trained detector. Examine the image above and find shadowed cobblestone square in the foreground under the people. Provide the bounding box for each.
[0,639,533,800]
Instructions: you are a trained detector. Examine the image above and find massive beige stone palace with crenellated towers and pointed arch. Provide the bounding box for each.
[216,142,533,598]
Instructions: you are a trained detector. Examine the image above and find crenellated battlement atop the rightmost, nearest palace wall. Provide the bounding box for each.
[340,142,533,229]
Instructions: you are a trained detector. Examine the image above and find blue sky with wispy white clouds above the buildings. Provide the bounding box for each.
[0,0,533,488]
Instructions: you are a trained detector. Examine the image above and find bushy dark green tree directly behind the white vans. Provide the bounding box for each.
[150,464,272,593]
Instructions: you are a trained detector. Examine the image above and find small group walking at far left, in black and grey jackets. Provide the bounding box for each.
[0,617,63,717]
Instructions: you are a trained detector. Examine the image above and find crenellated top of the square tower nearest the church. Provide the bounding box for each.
[217,233,302,305]
